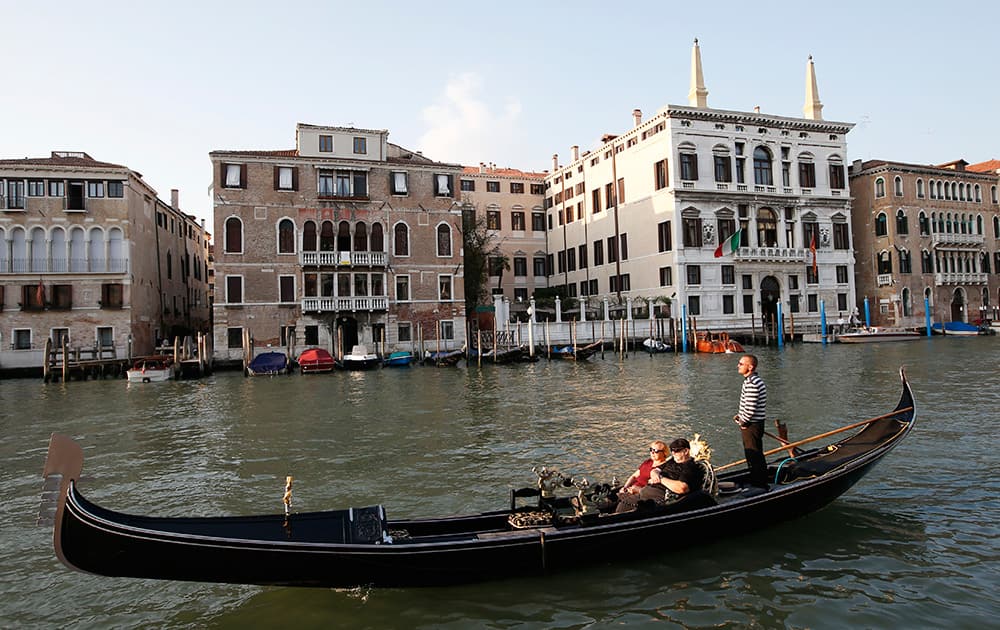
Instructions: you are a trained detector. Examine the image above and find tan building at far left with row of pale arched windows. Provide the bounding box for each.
[0,151,210,369]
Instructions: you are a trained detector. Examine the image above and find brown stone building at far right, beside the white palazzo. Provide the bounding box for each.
[850,160,1000,327]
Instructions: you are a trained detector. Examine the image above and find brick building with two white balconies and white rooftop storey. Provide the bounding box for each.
[210,123,465,362]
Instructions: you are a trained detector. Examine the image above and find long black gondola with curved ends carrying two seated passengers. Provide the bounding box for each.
[37,370,915,587]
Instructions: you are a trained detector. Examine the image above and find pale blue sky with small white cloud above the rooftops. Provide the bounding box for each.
[0,0,1000,231]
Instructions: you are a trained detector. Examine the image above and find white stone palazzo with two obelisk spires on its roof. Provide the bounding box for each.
[545,41,855,330]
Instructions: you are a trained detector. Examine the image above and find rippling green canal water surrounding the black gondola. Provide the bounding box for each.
[0,344,1000,629]
